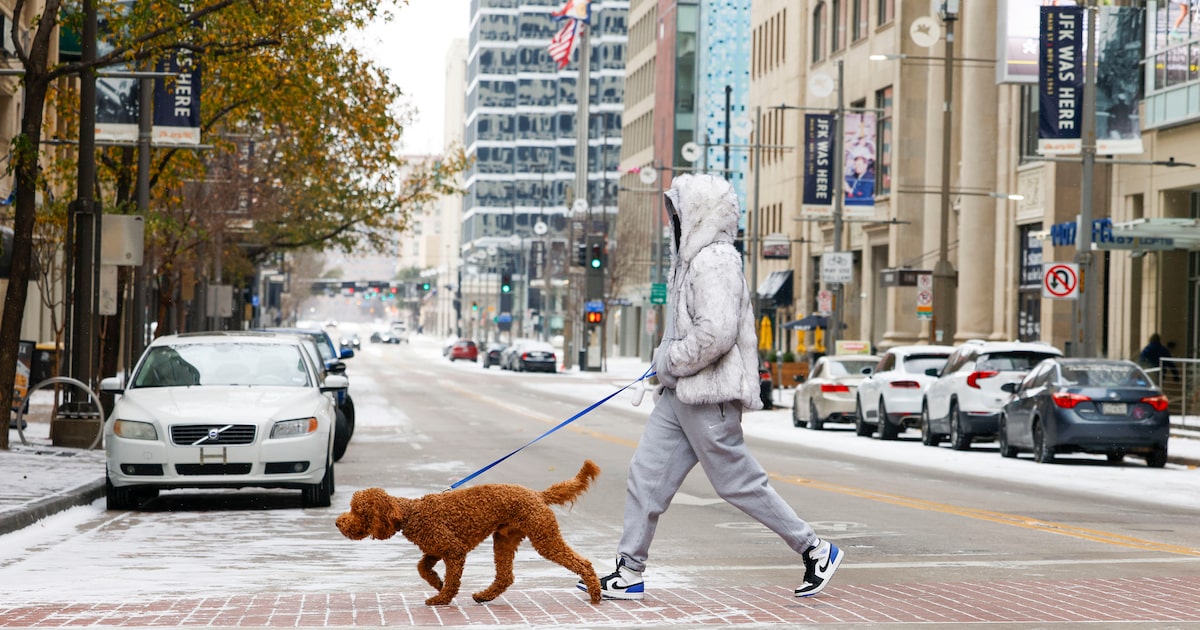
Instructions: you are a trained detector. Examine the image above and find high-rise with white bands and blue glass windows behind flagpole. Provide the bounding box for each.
[462,0,629,270]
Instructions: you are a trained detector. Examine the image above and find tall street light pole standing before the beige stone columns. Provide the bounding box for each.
[929,2,959,343]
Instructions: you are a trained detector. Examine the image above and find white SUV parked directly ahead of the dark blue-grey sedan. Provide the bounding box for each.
[920,340,1062,450]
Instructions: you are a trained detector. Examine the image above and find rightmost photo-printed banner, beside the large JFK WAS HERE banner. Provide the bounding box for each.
[1096,6,1146,155]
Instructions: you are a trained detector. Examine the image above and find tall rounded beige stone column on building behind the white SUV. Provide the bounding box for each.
[954,2,1007,341]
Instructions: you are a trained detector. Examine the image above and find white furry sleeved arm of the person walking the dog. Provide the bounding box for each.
[666,250,746,377]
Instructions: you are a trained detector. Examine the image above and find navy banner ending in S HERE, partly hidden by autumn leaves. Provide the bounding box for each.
[152,49,200,144]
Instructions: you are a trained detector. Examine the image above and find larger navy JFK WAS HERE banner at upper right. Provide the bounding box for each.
[1038,6,1085,155]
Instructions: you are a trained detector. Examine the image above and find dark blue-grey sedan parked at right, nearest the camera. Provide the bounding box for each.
[998,359,1170,468]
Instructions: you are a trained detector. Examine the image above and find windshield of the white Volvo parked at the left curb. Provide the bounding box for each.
[133,343,312,388]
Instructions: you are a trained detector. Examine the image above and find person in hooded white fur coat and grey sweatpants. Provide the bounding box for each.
[580,174,842,600]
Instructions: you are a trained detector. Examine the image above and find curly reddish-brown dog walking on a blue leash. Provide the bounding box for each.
[337,460,600,606]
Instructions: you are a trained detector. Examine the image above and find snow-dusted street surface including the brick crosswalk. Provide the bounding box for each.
[0,344,1200,628]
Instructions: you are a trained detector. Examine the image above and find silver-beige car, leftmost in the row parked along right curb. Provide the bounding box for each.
[792,354,880,431]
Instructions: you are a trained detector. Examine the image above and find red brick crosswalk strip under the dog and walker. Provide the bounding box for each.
[0,577,1200,628]
